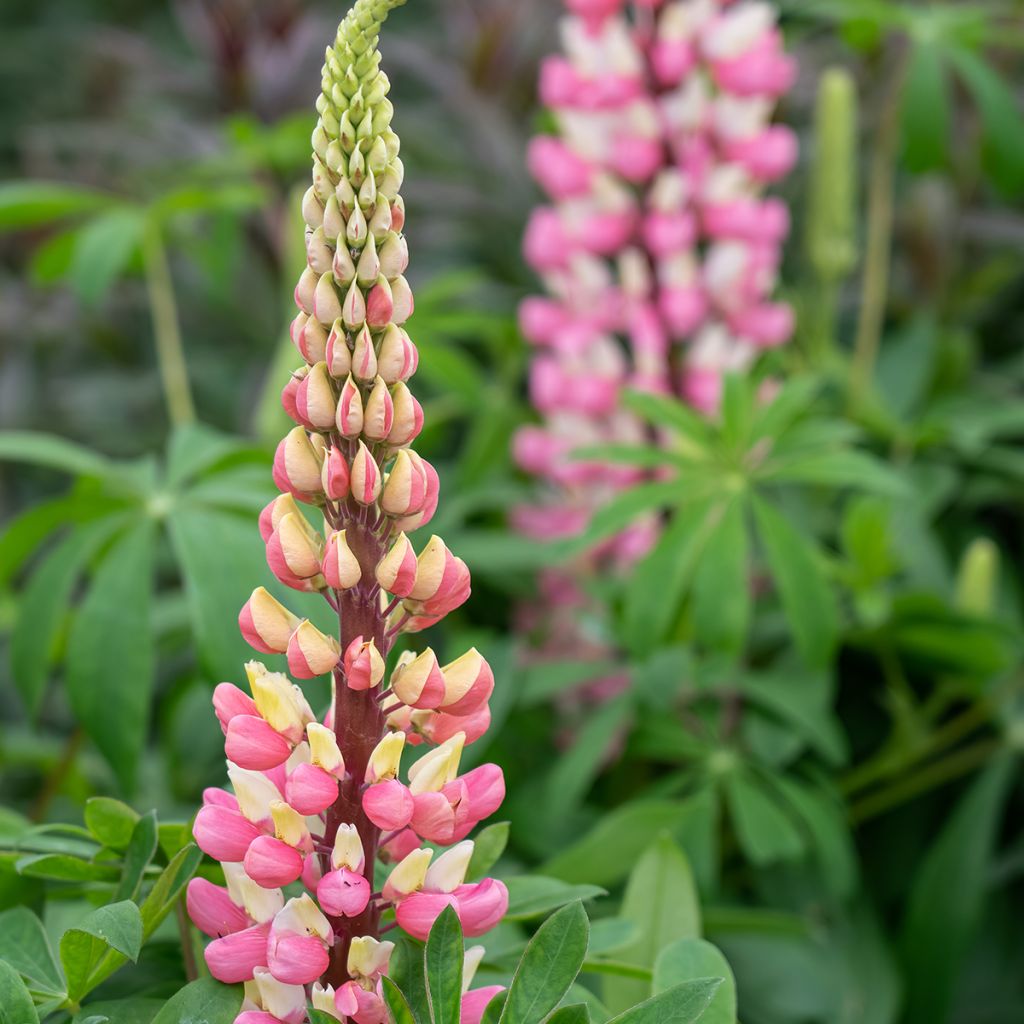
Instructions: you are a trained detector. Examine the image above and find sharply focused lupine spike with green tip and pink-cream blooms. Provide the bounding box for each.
[187,0,508,1024]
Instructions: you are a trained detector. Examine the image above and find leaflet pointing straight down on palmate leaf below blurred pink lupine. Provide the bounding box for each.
[693,497,751,654]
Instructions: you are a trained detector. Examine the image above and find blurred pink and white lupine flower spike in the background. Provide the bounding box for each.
[515,0,797,544]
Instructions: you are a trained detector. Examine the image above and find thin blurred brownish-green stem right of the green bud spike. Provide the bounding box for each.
[849,50,908,409]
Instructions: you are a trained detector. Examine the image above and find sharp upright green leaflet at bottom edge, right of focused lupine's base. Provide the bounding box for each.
[500,902,590,1024]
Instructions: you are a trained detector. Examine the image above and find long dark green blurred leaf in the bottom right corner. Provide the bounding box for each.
[901,754,1015,1024]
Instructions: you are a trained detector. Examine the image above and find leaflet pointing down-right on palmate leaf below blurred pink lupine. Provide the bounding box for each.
[754,497,839,668]
